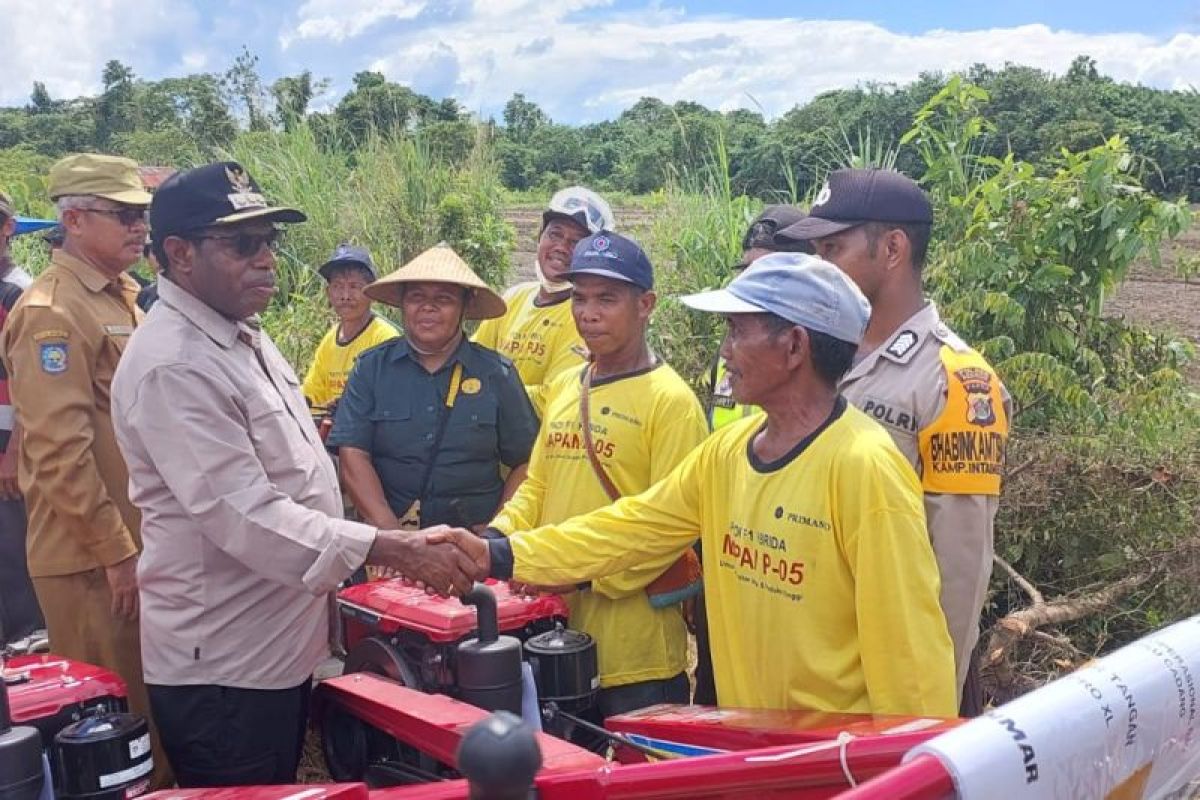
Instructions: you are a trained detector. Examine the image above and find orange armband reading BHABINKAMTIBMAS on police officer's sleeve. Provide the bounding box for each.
[920,345,1008,495]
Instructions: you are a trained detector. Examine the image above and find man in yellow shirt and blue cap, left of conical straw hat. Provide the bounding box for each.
[304,243,400,414]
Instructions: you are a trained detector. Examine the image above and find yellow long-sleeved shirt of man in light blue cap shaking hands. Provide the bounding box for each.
[509,402,956,716]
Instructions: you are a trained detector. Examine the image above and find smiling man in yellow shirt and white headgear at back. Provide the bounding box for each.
[474,186,616,414]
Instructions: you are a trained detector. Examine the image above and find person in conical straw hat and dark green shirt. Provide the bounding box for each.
[328,245,538,529]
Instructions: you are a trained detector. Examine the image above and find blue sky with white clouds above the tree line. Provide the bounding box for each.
[0,0,1200,122]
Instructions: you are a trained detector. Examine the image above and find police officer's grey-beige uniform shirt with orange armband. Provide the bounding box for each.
[841,302,1010,687]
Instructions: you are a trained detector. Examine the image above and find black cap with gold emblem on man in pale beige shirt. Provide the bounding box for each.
[150,161,307,242]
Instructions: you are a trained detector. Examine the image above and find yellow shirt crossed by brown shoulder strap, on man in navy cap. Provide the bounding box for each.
[491,365,708,687]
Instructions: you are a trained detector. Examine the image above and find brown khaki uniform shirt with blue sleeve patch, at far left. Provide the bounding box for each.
[0,249,142,577]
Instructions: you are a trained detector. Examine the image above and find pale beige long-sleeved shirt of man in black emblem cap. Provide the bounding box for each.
[113,279,376,690]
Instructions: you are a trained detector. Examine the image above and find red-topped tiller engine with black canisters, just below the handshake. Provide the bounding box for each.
[318,579,599,784]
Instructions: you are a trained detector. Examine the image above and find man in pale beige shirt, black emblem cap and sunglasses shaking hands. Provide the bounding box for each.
[113,162,472,787]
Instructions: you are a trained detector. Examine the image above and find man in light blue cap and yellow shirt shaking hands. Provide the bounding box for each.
[445,253,956,716]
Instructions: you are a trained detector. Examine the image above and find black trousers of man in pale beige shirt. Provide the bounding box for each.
[146,680,312,789]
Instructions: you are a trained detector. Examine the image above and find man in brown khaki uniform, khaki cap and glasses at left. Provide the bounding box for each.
[0,154,169,786]
